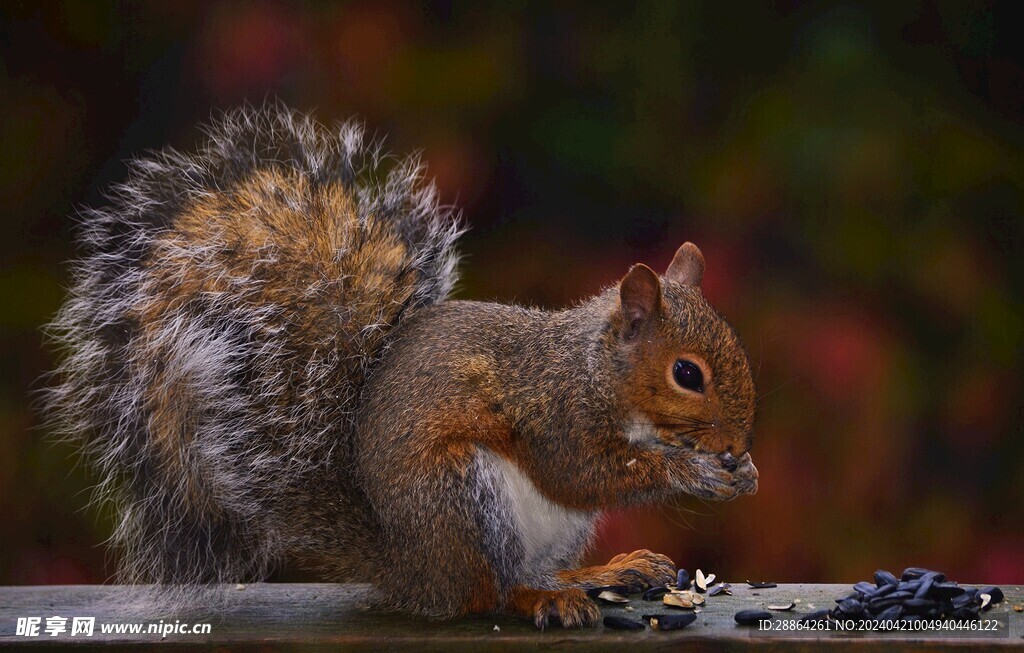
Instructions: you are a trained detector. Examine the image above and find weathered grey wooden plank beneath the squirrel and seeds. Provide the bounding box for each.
[0,582,1024,652]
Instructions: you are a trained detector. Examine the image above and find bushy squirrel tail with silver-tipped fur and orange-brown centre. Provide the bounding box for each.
[47,106,461,584]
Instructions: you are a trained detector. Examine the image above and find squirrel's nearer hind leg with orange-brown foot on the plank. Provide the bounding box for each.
[367,443,600,627]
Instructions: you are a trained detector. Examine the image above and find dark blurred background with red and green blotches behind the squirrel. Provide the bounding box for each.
[0,0,1024,584]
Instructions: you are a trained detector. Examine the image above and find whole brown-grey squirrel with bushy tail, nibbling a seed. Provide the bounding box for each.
[46,104,758,627]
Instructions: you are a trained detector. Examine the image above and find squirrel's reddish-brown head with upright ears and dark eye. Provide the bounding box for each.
[613,243,755,456]
